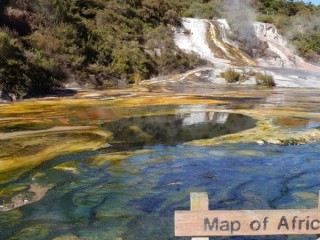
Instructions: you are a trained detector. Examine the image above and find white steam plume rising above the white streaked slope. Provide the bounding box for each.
[219,0,258,48]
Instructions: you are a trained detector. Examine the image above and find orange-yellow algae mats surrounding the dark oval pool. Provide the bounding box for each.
[0,87,320,185]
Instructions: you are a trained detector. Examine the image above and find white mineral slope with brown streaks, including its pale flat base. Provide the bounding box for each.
[175,18,320,88]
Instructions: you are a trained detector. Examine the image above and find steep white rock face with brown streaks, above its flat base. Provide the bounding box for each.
[175,18,320,72]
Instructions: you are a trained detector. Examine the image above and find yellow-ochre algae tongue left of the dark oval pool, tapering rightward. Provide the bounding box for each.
[0,130,111,183]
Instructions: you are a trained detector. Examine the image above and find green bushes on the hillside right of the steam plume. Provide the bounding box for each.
[257,0,320,62]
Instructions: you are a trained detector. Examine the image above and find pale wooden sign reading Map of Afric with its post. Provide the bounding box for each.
[175,193,320,239]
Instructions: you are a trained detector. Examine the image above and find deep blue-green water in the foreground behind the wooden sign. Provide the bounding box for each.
[0,143,320,240]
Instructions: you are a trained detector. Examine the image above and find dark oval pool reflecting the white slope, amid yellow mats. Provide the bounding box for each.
[104,112,256,146]
